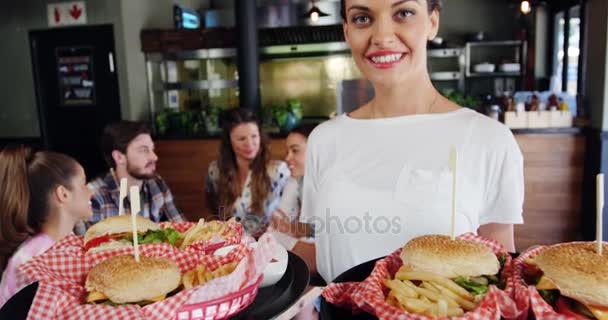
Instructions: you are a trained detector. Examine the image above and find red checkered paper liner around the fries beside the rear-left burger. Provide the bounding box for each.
[160,221,245,253]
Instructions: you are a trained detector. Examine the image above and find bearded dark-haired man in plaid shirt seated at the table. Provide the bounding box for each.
[75,121,185,234]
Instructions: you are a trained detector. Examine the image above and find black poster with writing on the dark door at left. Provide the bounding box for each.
[56,47,95,106]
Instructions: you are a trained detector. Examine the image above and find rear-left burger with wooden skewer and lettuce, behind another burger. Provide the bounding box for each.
[84,215,180,252]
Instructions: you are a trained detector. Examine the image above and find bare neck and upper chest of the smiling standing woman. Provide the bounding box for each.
[366,74,440,118]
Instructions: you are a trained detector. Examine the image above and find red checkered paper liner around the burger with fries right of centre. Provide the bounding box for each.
[323,233,519,320]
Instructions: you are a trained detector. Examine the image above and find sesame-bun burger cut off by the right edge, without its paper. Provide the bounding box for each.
[523,242,608,320]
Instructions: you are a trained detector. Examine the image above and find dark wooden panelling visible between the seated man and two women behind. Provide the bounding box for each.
[155,139,286,220]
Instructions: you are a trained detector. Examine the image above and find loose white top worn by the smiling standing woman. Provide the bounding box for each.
[300,108,524,282]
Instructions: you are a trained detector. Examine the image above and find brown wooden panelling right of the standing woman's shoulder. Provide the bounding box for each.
[515,134,585,251]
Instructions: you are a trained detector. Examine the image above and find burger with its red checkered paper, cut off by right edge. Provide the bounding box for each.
[511,242,608,320]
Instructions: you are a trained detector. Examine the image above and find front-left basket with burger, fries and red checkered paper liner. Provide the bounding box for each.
[17,223,277,319]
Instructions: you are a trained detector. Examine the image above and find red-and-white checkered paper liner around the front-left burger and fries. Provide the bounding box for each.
[18,231,277,320]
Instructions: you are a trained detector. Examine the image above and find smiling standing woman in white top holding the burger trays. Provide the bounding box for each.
[300,0,523,282]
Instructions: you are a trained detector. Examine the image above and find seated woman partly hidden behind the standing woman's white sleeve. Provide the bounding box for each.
[271,124,317,275]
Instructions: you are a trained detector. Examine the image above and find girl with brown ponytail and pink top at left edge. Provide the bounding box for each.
[0,147,92,307]
